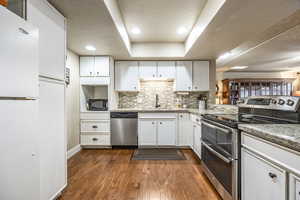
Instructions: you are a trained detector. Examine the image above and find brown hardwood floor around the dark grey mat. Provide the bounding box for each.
[59,149,221,200]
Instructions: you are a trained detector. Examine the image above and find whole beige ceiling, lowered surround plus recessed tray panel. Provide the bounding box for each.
[49,0,300,71]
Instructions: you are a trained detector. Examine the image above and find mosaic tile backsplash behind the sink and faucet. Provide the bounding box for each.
[119,81,208,109]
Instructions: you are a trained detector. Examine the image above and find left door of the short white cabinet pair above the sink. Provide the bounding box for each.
[139,61,157,79]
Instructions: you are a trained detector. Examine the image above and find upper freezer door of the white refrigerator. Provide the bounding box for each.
[0,6,39,97]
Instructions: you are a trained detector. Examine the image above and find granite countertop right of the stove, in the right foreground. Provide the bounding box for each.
[239,124,300,152]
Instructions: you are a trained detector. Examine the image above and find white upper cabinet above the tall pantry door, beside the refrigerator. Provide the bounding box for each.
[27,0,66,80]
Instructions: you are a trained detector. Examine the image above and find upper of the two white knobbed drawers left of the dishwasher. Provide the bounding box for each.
[81,120,110,133]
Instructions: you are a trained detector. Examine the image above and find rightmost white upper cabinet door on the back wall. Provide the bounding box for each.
[193,61,209,91]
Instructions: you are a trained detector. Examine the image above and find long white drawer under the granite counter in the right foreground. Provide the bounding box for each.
[242,132,300,174]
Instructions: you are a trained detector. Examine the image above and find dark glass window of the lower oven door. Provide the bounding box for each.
[201,145,233,195]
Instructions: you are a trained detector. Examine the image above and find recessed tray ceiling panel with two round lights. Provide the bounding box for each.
[118,0,207,42]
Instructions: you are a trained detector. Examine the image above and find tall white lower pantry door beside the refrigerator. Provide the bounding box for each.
[38,80,66,199]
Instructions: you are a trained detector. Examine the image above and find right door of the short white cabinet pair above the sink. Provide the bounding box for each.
[157,61,175,79]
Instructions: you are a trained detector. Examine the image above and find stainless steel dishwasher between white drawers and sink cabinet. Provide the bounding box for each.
[110,112,138,147]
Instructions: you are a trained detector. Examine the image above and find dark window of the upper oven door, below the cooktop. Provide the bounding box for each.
[202,122,233,156]
